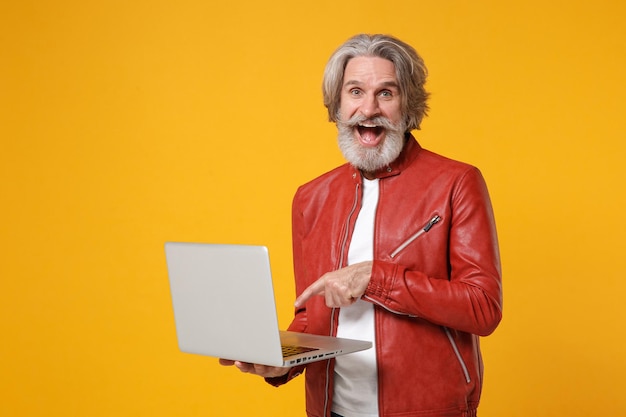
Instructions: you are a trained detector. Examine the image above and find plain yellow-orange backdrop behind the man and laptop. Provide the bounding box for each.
[0,0,626,417]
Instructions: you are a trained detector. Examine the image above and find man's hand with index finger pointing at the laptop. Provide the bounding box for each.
[295,261,372,308]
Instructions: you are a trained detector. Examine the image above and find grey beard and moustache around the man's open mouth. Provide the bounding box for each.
[337,116,406,173]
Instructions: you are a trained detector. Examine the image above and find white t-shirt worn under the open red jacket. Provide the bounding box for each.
[332,179,378,417]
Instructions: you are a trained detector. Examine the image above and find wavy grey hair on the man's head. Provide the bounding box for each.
[322,34,428,131]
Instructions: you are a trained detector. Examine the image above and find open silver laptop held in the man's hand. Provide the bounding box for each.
[165,242,372,366]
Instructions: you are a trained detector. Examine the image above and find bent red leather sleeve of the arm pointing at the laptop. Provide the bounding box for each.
[365,169,502,336]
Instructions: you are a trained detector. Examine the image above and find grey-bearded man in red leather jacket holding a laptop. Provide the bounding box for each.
[222,35,502,417]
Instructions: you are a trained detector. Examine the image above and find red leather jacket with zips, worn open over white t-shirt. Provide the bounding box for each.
[270,137,502,417]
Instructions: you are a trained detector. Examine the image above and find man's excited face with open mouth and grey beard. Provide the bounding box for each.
[337,56,406,177]
